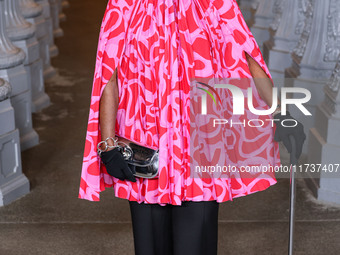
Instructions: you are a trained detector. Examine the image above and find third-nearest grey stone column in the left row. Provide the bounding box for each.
[5,0,50,112]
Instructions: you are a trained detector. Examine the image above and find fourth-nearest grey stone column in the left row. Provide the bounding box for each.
[19,0,56,80]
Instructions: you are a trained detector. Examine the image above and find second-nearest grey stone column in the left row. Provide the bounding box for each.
[0,0,39,150]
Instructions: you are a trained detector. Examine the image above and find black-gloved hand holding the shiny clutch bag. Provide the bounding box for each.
[100,147,136,182]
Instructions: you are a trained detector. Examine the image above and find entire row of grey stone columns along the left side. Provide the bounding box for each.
[0,0,68,206]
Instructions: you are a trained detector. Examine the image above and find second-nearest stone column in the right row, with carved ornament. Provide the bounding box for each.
[285,0,340,154]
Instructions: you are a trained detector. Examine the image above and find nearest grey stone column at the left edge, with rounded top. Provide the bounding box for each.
[0,78,30,207]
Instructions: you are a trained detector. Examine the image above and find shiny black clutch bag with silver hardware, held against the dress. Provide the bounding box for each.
[116,136,159,178]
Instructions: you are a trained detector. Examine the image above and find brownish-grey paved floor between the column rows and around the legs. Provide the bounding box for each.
[0,0,340,255]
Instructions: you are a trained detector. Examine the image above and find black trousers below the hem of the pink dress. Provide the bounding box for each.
[129,201,219,255]
